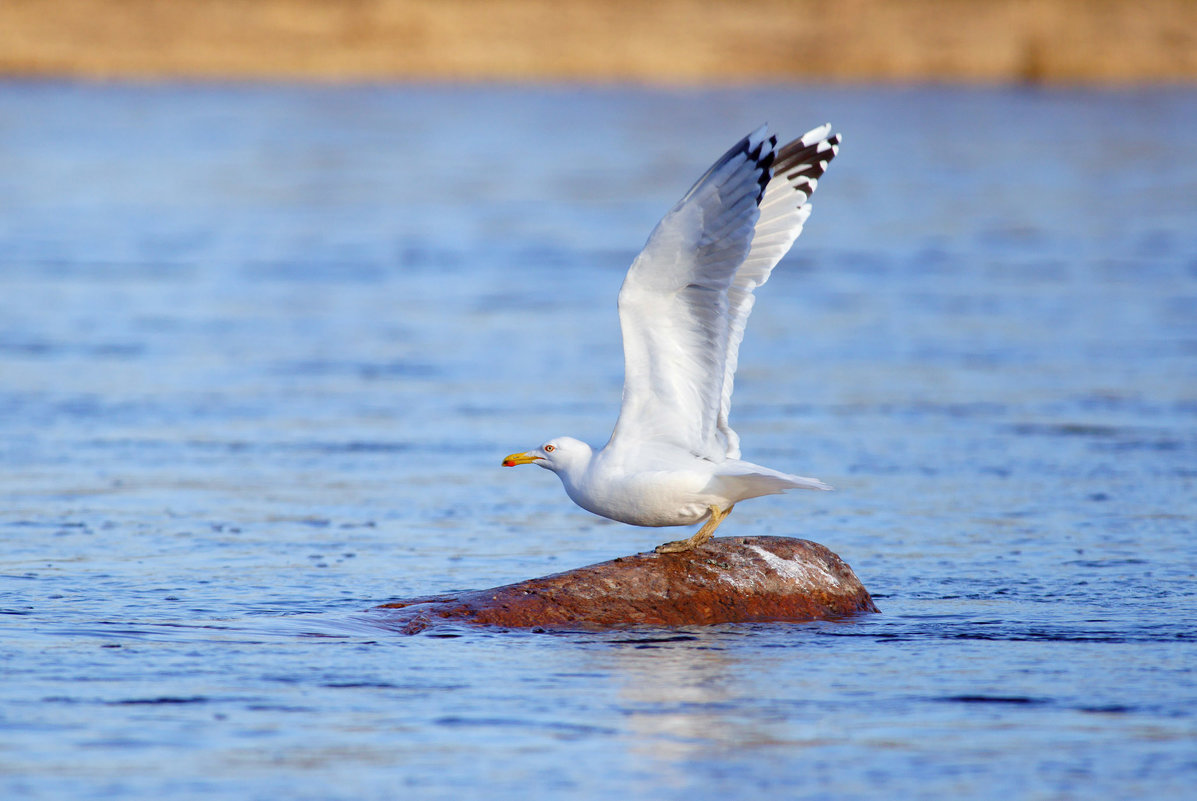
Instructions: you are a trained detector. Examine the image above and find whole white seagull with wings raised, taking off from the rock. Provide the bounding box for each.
[503,125,840,553]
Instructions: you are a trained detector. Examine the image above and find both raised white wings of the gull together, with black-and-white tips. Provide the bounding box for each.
[608,126,839,462]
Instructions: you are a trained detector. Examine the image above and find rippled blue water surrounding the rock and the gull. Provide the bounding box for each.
[0,83,1197,799]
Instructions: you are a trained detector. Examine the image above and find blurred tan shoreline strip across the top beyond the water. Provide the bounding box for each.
[0,0,1197,85]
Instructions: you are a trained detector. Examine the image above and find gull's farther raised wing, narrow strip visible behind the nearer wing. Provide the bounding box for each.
[717,123,840,459]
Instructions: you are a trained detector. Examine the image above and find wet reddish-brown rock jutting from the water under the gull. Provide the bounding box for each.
[373,536,877,633]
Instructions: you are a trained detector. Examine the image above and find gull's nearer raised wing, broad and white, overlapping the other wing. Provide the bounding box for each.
[608,127,777,461]
